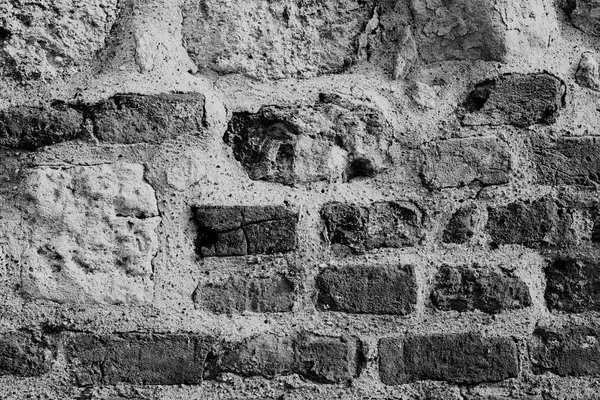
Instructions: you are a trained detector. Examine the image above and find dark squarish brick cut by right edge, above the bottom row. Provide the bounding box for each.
[544,256,600,313]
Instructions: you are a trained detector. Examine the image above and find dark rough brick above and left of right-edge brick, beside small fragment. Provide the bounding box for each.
[485,197,573,248]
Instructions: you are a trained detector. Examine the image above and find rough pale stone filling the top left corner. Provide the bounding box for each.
[0,0,117,80]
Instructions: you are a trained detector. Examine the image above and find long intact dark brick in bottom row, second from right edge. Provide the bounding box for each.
[379,334,519,385]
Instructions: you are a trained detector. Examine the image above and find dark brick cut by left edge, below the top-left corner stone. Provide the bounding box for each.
[0,102,83,150]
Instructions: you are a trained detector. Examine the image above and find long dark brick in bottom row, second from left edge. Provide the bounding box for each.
[66,334,212,386]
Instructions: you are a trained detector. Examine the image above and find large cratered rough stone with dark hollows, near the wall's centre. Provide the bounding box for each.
[224,94,393,186]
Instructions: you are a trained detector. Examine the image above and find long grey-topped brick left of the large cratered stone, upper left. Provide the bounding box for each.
[86,93,205,144]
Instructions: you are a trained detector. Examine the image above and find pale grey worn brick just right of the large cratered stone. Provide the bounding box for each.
[421,136,512,189]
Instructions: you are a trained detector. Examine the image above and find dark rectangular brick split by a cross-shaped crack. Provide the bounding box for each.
[194,206,298,257]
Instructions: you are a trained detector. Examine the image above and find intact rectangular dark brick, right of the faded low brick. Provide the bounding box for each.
[316,265,417,315]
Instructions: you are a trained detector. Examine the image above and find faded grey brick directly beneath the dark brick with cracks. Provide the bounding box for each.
[193,274,296,314]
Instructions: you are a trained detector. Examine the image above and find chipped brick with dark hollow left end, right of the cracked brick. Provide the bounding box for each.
[321,202,425,253]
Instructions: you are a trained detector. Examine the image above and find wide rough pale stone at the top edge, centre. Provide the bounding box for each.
[183,0,374,79]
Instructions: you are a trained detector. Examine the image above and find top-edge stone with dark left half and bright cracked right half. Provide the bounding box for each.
[411,0,557,62]
